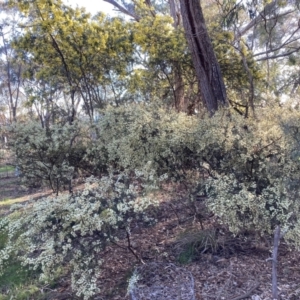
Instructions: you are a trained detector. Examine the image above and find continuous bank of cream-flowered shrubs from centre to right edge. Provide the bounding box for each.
[97,105,300,246]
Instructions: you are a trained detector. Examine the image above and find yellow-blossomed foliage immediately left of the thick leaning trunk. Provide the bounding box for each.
[129,13,190,106]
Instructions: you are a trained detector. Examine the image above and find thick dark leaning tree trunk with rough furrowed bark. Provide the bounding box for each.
[180,0,228,115]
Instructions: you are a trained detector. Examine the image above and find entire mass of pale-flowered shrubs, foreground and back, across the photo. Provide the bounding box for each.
[0,105,300,299]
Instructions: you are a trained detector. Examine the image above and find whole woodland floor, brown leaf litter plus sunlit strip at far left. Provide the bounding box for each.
[0,178,300,300]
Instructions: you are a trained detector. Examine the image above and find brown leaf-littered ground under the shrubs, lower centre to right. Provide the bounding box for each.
[95,190,300,300]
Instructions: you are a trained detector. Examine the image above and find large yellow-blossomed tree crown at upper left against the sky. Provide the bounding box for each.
[11,0,134,121]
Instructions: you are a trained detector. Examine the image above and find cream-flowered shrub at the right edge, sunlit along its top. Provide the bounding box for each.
[206,107,300,247]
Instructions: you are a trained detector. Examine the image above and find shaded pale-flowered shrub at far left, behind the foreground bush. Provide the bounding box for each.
[13,122,85,192]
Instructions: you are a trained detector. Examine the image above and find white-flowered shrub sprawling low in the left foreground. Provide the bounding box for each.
[0,175,157,299]
